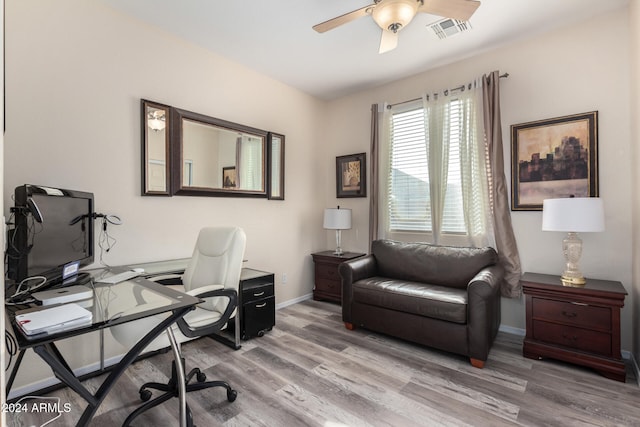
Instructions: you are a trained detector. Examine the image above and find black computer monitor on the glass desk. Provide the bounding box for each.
[7,184,94,284]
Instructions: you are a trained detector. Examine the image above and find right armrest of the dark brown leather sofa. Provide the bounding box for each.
[467,265,504,361]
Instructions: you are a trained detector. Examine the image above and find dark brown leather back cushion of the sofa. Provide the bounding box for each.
[371,240,498,289]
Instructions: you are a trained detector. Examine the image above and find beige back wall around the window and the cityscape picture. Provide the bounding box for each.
[323,10,637,351]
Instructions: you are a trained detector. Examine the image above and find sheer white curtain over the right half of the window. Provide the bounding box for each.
[422,79,495,247]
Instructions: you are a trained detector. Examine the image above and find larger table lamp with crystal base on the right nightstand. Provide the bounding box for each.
[542,197,604,286]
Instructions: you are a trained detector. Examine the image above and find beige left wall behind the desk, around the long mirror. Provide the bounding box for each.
[3,0,326,387]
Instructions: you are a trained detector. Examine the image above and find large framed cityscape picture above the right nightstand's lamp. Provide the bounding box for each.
[511,111,598,211]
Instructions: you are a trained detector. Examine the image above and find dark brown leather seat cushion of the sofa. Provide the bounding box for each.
[353,276,467,324]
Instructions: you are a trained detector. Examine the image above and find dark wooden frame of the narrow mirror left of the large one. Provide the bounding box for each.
[140,99,172,196]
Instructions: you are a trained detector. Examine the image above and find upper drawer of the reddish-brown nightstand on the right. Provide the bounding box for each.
[532,298,611,332]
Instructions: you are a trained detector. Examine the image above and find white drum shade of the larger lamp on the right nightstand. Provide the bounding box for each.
[542,197,604,233]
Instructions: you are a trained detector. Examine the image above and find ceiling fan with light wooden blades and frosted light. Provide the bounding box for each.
[313,0,480,53]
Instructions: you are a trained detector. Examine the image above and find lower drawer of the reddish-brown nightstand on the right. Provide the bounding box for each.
[533,320,612,356]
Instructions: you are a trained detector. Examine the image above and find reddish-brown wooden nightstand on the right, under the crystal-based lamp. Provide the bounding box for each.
[520,273,627,382]
